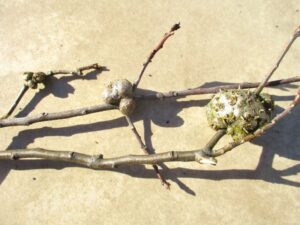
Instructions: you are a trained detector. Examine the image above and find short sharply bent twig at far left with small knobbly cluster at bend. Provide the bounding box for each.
[1,63,106,119]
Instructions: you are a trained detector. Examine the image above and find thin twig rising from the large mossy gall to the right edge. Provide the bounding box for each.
[255,26,300,95]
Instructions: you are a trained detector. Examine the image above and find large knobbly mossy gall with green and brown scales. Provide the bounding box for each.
[206,89,274,141]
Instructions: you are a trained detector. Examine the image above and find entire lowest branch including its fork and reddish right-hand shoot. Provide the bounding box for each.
[0,90,300,169]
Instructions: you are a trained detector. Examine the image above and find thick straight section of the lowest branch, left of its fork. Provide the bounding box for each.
[0,148,210,169]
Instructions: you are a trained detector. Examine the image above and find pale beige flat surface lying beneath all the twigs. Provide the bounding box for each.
[0,0,300,225]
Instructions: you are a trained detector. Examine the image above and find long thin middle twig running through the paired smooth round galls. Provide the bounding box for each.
[0,77,300,127]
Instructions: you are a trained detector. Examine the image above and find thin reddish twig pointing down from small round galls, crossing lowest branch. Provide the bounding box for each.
[125,116,171,190]
